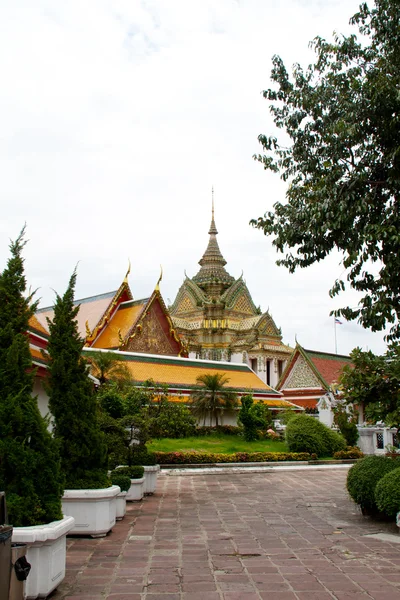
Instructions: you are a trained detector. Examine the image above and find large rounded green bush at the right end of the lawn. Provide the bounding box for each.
[285,415,346,456]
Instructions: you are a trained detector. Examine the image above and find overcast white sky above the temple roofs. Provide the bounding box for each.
[0,0,385,354]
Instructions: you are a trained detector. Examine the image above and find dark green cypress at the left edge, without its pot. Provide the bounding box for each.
[0,228,63,527]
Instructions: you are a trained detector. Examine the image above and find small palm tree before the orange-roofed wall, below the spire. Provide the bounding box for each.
[191,373,238,427]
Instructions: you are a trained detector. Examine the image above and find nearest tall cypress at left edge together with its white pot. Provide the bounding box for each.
[0,229,74,598]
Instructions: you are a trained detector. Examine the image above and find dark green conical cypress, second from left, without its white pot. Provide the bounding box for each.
[47,270,110,489]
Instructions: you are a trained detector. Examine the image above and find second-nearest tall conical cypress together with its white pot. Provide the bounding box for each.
[47,270,120,537]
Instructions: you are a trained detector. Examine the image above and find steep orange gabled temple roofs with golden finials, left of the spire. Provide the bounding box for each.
[36,269,187,356]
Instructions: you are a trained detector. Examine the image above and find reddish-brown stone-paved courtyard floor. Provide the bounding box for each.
[51,469,400,600]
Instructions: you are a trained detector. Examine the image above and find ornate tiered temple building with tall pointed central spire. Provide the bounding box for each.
[169,201,293,387]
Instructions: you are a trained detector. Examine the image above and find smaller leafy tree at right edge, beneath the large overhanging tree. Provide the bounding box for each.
[340,344,400,434]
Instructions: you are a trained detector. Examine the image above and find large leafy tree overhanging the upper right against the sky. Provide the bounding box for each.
[251,0,400,340]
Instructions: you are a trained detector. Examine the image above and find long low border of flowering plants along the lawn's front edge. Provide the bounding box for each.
[155,452,316,465]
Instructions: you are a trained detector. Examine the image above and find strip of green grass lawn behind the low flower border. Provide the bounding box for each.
[147,434,288,454]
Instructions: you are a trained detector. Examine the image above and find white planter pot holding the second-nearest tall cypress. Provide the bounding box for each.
[62,485,121,537]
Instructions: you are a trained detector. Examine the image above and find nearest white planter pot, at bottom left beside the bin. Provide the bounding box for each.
[12,516,75,600]
